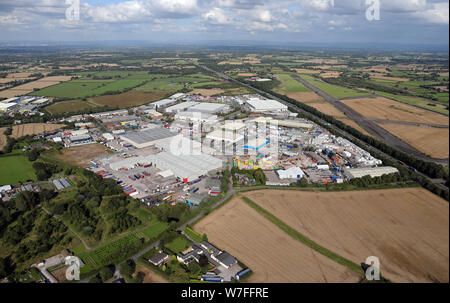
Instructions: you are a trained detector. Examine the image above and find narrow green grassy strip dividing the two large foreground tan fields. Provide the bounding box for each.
[240,196,364,276]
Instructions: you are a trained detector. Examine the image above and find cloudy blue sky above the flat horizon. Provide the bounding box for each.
[0,0,449,45]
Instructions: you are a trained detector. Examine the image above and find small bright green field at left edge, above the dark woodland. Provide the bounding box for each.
[0,155,36,186]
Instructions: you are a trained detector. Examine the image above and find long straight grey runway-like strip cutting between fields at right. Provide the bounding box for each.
[291,74,448,164]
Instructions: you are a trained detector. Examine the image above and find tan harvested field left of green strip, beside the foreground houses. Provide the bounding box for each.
[194,197,360,283]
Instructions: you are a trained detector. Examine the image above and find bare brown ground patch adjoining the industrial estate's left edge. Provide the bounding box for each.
[53,144,111,167]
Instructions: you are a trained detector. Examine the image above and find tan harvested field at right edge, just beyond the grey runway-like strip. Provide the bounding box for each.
[341,97,449,125]
